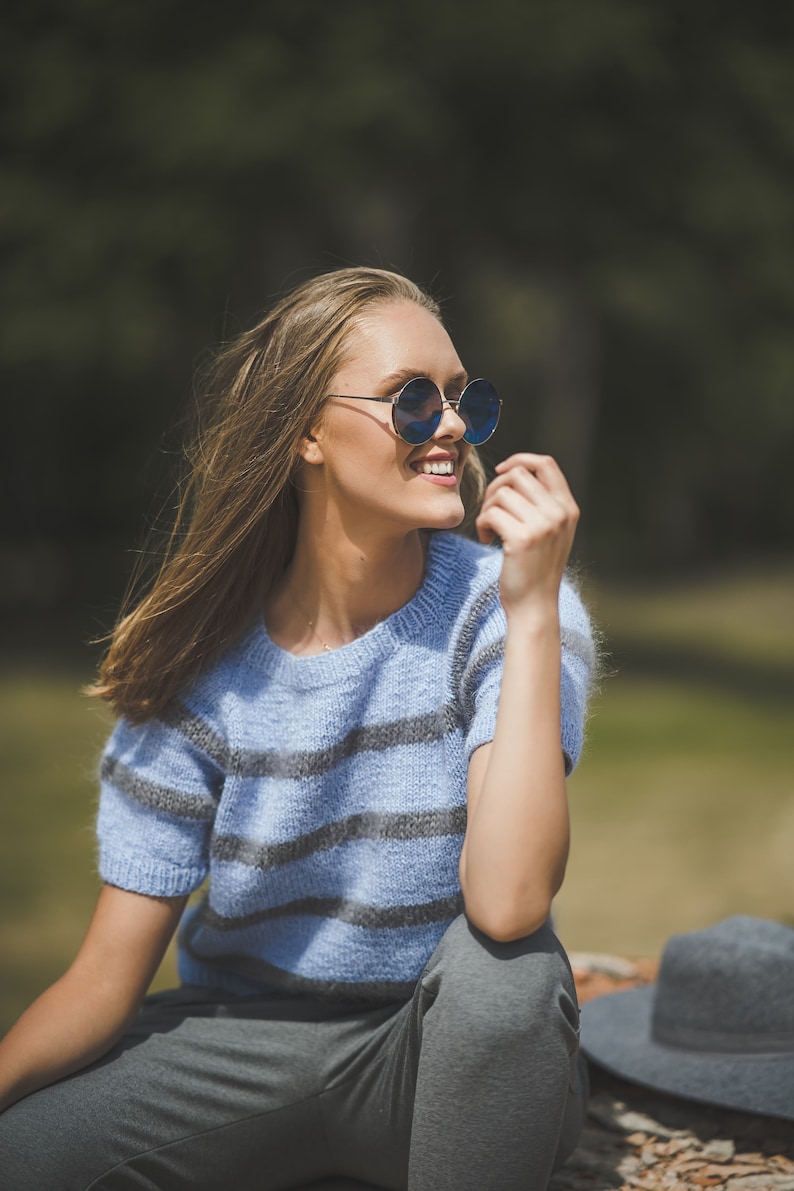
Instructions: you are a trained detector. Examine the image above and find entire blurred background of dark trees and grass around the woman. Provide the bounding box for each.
[0,0,794,1011]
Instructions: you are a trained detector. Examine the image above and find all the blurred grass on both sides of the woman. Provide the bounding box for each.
[0,570,794,1029]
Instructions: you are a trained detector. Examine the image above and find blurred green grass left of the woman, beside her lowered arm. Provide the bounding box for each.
[0,665,182,1031]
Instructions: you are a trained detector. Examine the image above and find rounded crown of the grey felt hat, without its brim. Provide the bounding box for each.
[652,916,794,1053]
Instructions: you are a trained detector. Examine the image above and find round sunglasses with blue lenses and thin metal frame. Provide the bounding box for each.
[329,376,501,447]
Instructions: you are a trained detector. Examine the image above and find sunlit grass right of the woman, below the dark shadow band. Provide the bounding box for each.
[556,674,794,955]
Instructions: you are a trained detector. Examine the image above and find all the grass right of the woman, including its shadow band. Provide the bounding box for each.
[555,569,794,955]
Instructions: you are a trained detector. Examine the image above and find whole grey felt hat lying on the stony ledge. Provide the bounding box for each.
[582,917,794,1121]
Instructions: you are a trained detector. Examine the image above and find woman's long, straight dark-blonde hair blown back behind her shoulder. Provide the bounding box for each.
[88,268,484,723]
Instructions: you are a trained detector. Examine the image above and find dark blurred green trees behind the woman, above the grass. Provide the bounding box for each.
[0,0,794,624]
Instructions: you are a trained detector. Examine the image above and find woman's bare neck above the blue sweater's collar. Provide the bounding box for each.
[265,519,426,654]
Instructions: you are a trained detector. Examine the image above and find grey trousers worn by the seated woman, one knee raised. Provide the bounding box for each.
[0,917,587,1191]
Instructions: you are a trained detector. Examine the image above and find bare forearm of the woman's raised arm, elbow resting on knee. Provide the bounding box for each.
[461,604,569,939]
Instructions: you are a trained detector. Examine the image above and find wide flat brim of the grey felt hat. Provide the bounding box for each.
[581,986,794,1121]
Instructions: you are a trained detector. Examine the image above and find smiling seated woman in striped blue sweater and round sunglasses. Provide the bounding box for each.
[0,269,590,1191]
